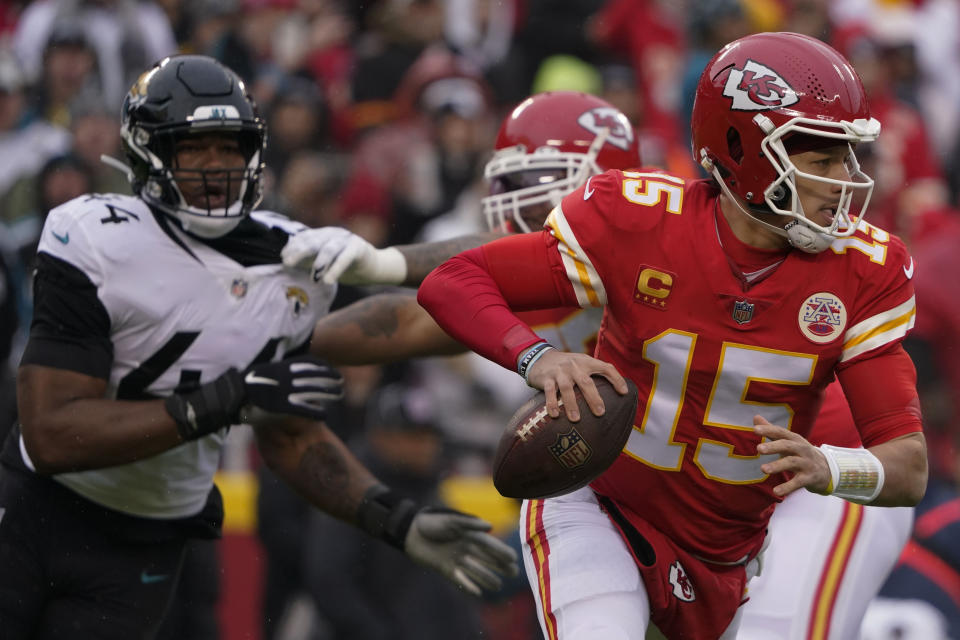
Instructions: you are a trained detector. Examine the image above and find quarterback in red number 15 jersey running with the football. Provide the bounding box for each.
[419,33,926,639]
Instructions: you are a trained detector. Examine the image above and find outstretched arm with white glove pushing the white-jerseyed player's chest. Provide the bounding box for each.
[282,227,503,287]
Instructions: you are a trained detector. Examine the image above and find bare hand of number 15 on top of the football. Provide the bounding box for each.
[527,349,627,422]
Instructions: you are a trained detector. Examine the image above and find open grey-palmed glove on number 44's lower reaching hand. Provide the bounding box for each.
[403,508,518,596]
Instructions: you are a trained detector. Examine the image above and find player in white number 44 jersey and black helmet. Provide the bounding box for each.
[0,56,516,640]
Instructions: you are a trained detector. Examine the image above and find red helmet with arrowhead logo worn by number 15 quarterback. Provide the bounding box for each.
[690,33,880,253]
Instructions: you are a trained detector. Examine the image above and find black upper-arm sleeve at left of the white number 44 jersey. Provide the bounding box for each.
[20,253,113,379]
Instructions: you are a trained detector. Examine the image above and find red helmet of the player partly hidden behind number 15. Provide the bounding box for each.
[483,91,640,232]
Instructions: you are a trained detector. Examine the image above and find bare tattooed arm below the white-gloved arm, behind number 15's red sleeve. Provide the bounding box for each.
[310,291,466,365]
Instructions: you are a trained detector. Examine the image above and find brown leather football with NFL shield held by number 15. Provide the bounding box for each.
[493,376,637,498]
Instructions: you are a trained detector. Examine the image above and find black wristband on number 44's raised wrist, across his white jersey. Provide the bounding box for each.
[164,368,244,441]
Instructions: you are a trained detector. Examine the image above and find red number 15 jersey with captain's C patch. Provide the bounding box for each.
[547,171,915,561]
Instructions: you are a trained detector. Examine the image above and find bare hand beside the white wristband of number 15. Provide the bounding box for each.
[753,416,830,498]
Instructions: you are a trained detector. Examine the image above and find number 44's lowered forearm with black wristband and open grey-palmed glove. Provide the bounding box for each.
[255,418,518,595]
